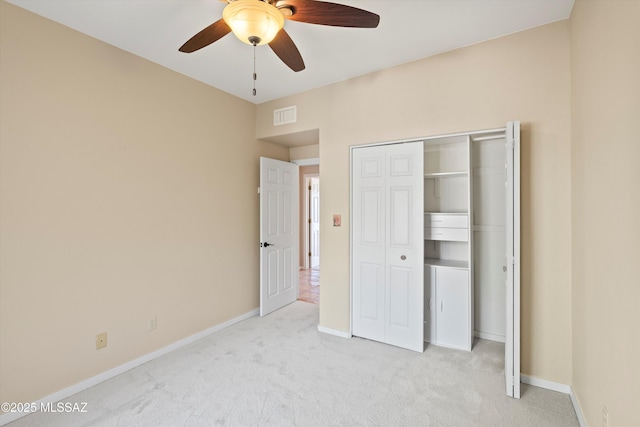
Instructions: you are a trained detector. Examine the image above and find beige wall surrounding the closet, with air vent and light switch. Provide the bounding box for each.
[257,21,571,384]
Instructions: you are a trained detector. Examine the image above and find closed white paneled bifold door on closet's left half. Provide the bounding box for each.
[351,142,424,352]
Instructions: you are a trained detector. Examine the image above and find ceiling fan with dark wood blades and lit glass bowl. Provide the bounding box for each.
[179,0,380,72]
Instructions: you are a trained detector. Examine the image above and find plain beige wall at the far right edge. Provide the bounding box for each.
[571,0,640,426]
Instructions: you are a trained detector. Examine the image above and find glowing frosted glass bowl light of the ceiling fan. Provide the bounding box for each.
[222,0,284,46]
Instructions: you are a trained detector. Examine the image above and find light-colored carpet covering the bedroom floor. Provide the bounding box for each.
[9,301,578,427]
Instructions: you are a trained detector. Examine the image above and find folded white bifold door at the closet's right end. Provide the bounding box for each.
[504,122,520,399]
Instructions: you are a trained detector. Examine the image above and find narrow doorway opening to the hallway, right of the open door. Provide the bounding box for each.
[298,165,320,304]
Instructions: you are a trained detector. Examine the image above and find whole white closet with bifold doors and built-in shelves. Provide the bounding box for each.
[351,122,520,397]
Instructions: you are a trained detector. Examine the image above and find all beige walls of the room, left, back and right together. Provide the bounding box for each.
[8,0,640,425]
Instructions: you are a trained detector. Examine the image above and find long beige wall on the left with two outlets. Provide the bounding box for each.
[0,2,288,402]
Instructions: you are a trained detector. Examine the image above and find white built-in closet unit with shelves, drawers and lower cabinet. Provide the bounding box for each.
[424,135,473,350]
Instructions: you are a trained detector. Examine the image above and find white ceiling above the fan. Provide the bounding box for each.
[7,0,574,104]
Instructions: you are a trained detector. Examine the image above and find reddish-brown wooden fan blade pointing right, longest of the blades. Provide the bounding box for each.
[276,0,380,28]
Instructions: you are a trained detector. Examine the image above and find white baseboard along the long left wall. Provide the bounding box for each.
[0,308,260,426]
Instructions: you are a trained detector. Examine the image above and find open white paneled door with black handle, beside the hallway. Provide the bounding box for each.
[260,157,299,316]
